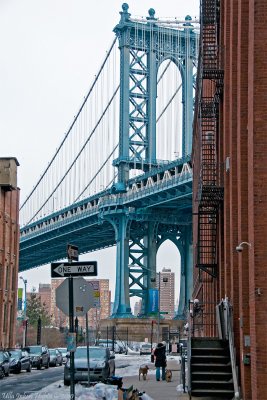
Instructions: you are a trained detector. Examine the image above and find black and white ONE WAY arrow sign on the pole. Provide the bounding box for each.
[51,261,97,278]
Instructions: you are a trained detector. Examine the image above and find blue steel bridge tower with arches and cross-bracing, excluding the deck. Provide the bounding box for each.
[107,3,198,318]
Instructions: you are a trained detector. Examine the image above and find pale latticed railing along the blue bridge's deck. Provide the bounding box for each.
[20,157,192,242]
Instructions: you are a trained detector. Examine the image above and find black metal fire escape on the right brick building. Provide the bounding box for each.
[196,0,223,282]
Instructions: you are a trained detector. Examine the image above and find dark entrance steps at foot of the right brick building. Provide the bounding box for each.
[191,338,234,400]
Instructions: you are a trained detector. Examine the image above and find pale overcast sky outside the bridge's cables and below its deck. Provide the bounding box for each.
[0,0,199,306]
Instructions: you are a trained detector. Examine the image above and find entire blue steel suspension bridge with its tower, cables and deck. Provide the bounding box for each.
[19,3,199,318]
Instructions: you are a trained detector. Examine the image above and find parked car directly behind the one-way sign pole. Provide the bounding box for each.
[64,346,115,386]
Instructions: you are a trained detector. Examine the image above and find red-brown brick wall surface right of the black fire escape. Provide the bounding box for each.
[194,0,267,400]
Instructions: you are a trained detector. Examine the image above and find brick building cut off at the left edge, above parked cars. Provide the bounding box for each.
[0,158,19,348]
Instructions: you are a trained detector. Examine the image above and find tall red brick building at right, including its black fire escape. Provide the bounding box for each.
[193,0,267,400]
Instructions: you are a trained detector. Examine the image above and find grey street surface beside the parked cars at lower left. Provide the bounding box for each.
[0,366,64,400]
